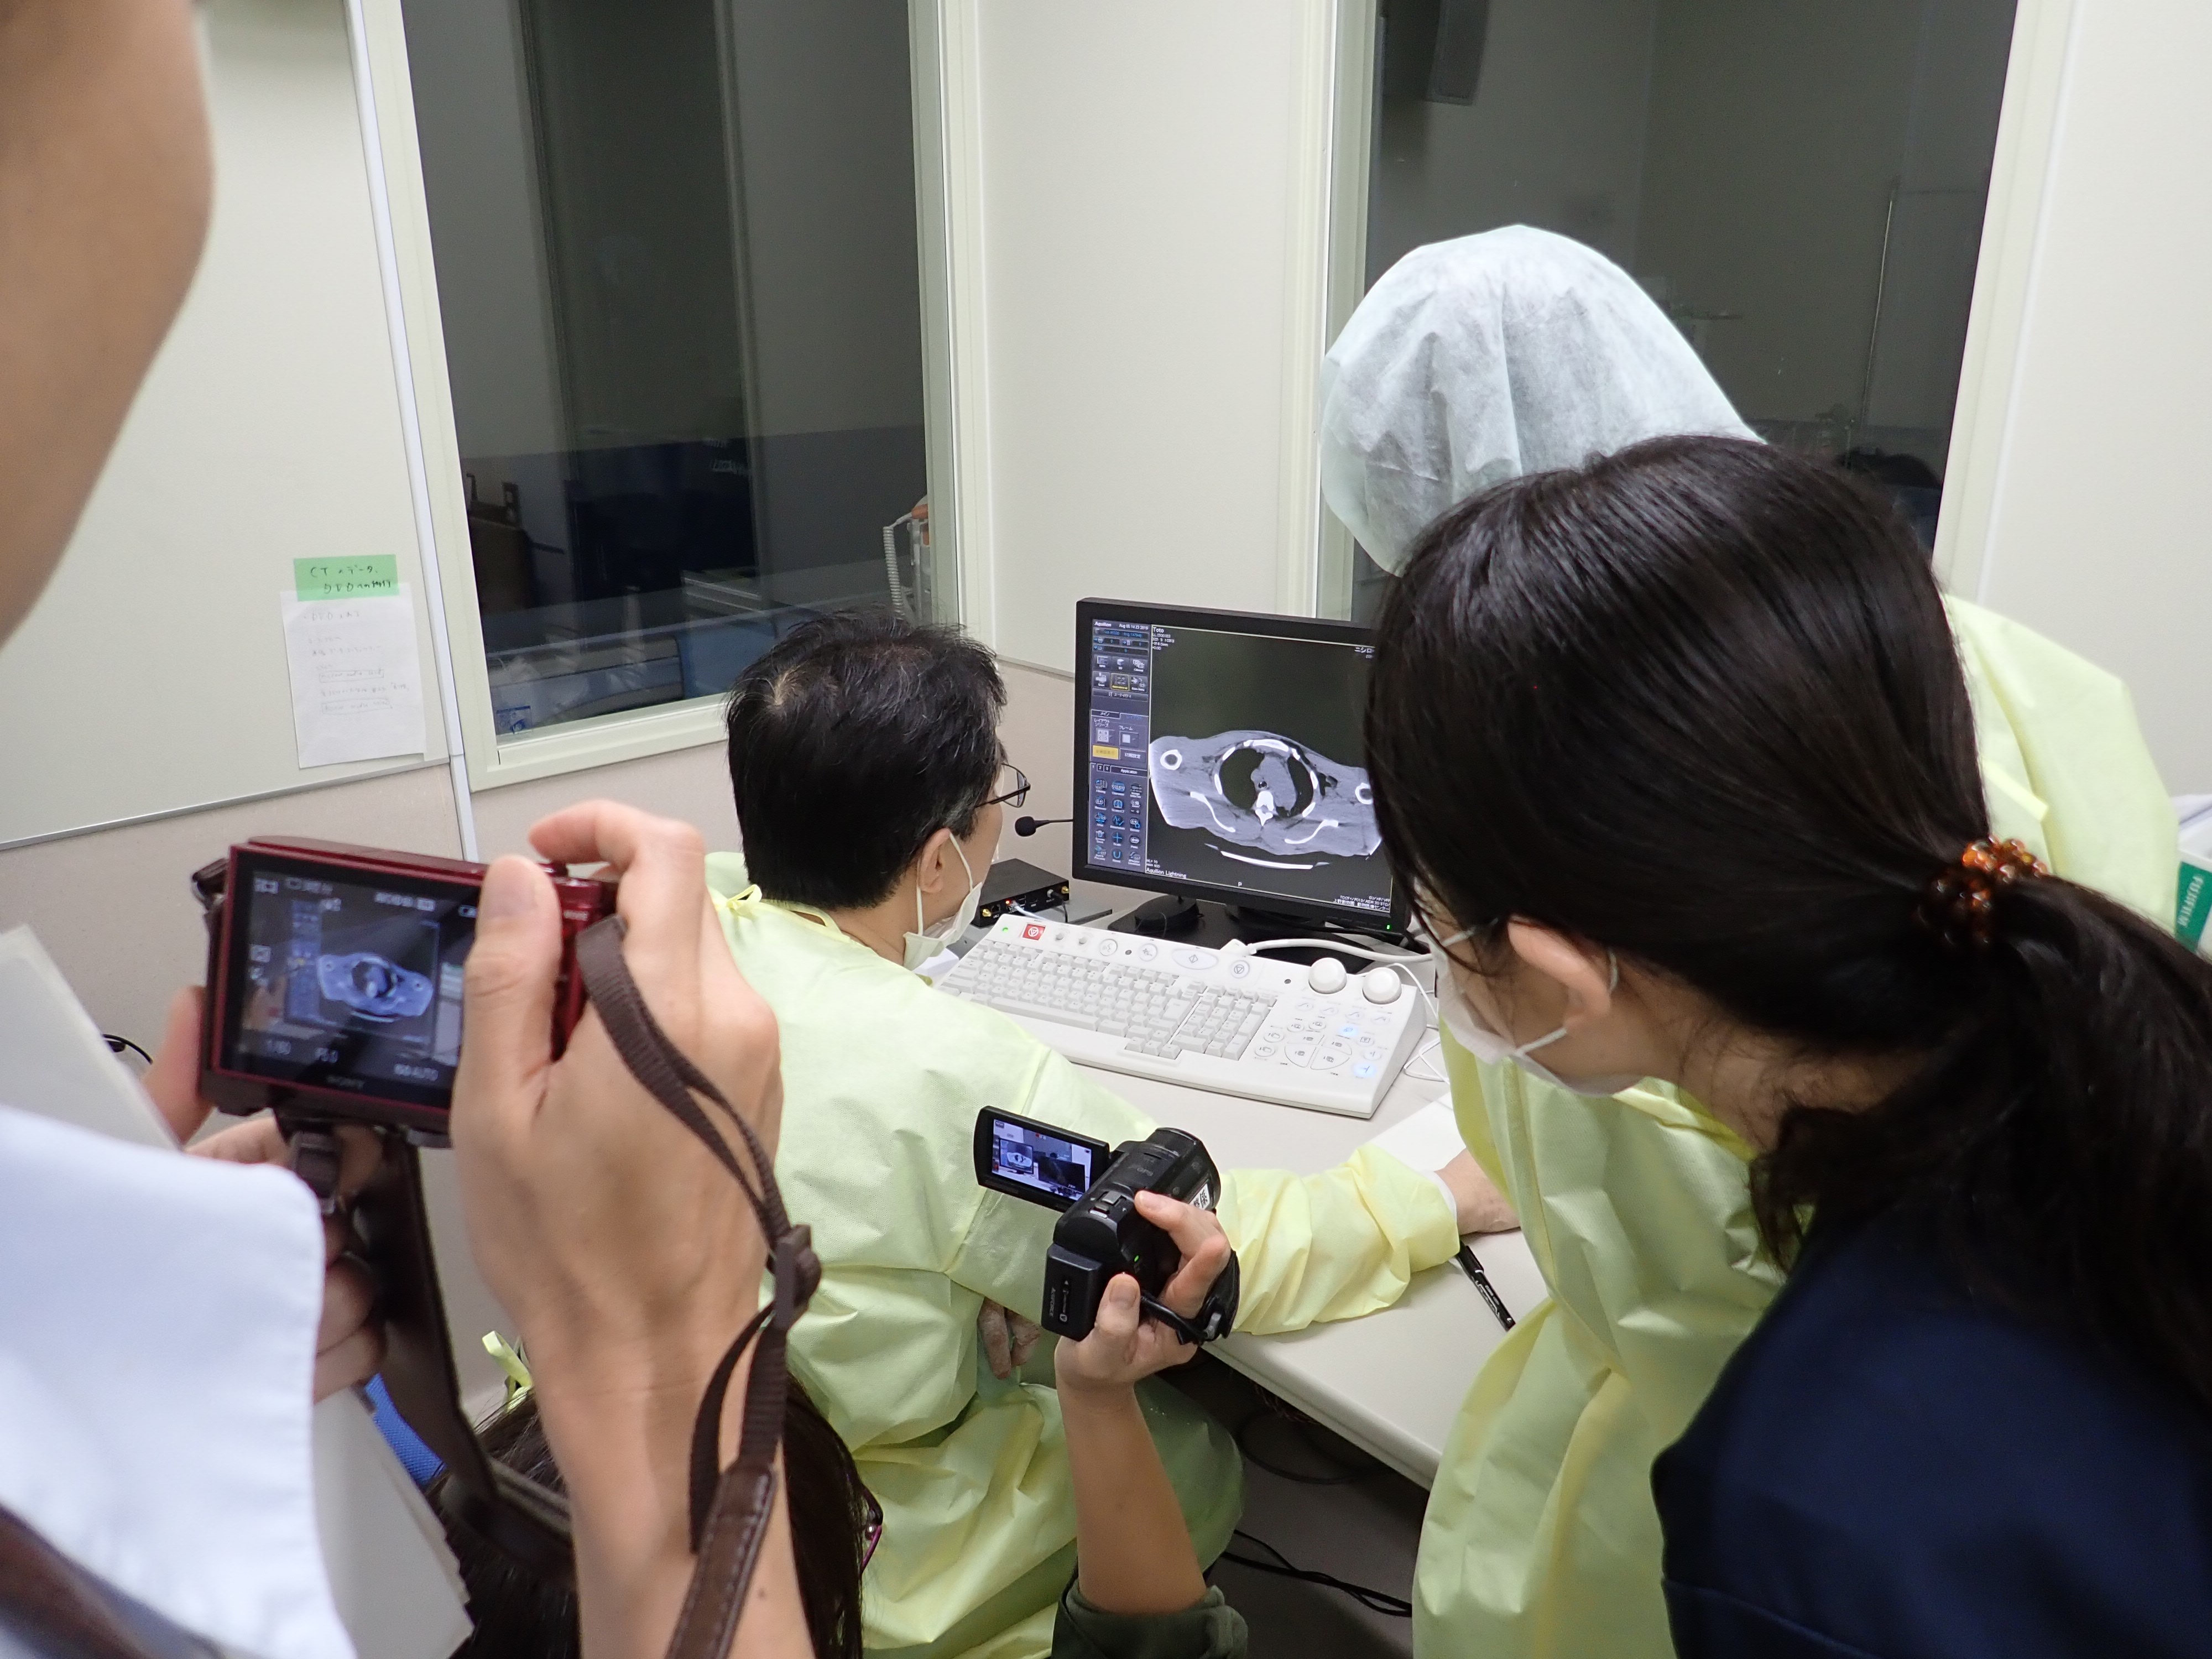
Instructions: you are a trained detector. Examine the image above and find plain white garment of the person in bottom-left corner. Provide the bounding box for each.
[0,1106,354,1659]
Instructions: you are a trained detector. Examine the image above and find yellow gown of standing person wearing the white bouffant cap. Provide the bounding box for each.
[1413,599,2177,1659]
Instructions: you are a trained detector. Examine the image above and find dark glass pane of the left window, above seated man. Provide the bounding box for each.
[403,0,931,734]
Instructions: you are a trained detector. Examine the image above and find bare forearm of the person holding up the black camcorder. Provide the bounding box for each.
[1060,1385,1206,1613]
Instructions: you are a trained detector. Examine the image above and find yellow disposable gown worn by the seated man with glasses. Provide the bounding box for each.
[708,854,1458,1659]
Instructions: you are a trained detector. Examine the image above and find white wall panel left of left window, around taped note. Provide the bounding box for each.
[0,0,445,849]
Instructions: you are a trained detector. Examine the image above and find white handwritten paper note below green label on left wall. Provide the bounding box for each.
[279,582,422,768]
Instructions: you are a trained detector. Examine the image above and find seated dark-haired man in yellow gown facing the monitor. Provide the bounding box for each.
[708,615,1486,1659]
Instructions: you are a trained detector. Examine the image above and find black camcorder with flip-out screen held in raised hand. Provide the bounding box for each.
[975,1106,1239,1343]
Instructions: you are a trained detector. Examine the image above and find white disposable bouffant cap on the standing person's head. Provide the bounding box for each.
[1321,226,1756,571]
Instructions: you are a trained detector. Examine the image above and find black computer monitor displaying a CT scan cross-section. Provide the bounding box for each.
[1073,599,1405,929]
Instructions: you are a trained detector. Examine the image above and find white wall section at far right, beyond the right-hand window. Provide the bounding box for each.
[1955,0,2212,792]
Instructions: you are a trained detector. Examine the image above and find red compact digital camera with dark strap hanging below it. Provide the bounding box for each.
[192,841,615,1577]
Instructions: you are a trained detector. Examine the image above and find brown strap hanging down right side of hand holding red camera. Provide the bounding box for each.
[575,916,821,1659]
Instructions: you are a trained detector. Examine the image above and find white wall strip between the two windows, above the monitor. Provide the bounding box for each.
[956,0,1325,672]
